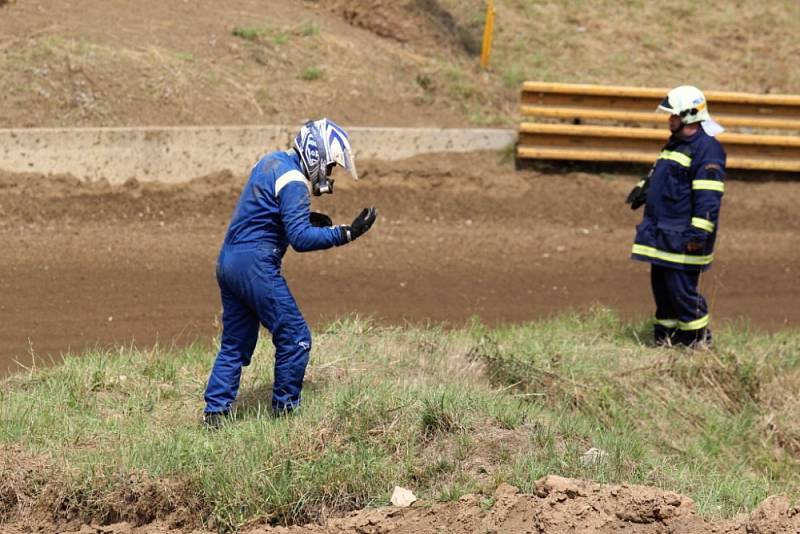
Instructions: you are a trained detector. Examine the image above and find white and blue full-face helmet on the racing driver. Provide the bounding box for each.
[294,119,358,195]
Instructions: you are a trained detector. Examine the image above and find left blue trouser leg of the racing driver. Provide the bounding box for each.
[205,253,259,413]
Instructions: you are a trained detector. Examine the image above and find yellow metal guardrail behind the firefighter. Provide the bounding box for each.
[517,82,800,172]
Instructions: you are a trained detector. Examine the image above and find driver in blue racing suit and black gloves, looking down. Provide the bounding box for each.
[203,119,377,427]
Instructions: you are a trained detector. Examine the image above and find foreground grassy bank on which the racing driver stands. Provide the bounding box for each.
[0,310,800,530]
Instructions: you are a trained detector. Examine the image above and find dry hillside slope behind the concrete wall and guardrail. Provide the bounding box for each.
[0,0,800,127]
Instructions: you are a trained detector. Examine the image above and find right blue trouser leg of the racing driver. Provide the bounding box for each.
[252,271,311,412]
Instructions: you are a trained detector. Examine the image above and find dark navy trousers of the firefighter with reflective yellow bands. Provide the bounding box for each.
[651,265,709,345]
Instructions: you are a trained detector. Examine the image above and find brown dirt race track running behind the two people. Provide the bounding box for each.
[0,154,800,370]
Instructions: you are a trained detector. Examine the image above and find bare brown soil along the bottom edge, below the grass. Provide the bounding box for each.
[0,447,800,534]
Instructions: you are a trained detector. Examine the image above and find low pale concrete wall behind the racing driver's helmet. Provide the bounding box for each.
[0,126,516,183]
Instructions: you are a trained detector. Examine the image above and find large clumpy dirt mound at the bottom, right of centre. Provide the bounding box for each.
[290,482,708,533]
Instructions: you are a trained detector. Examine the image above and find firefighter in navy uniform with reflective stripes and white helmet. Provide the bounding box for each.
[627,85,725,347]
